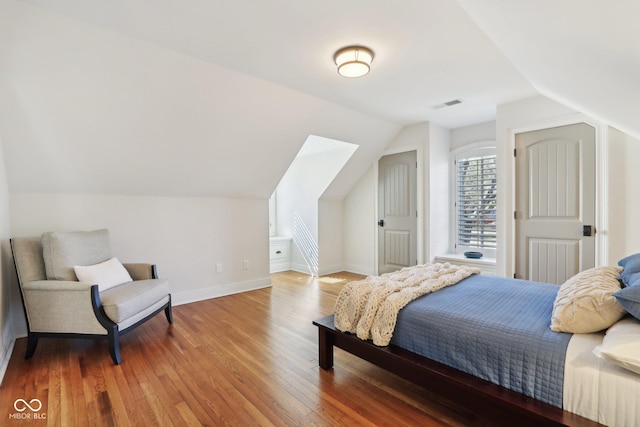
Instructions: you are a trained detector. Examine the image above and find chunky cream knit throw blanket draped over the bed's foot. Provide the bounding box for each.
[334,263,480,346]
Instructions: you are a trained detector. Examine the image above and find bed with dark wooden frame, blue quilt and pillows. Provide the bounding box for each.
[314,260,640,427]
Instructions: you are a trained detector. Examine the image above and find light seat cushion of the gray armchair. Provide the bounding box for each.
[100,279,169,323]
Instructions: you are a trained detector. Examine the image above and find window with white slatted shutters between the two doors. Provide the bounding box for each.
[454,147,497,256]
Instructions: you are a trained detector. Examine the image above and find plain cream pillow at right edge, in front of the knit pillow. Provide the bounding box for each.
[593,317,640,374]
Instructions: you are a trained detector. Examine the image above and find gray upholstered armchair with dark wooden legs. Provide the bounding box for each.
[11,230,173,365]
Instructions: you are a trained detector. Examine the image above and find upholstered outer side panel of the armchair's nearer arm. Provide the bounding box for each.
[22,280,107,335]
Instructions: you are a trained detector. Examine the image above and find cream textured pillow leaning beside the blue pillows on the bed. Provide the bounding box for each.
[551,266,626,334]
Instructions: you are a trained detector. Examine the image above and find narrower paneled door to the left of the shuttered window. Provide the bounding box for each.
[378,151,418,274]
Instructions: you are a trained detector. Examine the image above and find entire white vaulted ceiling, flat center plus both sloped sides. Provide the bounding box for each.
[0,0,640,198]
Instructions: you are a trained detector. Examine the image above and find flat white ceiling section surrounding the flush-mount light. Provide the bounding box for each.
[18,0,535,128]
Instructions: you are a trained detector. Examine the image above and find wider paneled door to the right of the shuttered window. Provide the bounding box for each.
[515,123,596,284]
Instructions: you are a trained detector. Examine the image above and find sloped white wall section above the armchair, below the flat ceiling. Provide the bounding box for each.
[0,1,399,203]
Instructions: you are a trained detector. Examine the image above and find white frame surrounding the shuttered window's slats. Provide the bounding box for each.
[450,141,498,258]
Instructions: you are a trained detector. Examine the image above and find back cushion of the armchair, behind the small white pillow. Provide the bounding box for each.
[42,229,111,280]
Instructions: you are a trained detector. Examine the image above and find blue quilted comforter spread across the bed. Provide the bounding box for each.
[391,275,571,408]
